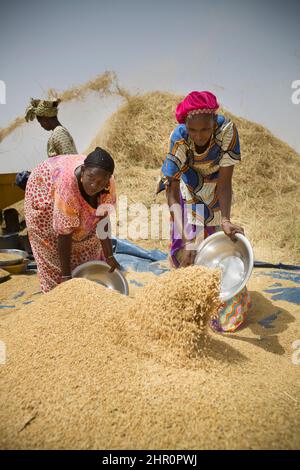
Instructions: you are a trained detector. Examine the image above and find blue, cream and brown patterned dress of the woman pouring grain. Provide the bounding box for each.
[158,115,250,331]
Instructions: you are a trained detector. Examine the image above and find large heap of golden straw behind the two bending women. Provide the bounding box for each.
[87,91,300,263]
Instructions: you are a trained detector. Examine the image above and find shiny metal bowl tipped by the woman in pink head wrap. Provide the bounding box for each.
[195,232,254,302]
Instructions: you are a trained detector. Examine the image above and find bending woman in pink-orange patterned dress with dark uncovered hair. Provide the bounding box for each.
[25,147,119,292]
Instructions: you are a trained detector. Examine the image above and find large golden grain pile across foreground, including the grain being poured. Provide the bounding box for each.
[0,267,300,449]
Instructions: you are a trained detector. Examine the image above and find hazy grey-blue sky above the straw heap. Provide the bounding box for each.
[0,0,300,152]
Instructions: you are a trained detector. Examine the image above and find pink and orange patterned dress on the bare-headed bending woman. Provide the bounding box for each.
[24,155,116,292]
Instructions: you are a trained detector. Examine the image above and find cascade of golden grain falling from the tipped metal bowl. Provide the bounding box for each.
[126,266,220,357]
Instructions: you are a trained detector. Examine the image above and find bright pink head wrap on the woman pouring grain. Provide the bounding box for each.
[176,91,219,124]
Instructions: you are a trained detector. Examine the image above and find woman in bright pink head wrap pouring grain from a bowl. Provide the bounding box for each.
[158,91,250,331]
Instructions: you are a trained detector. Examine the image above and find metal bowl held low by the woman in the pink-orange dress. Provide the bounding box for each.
[72,261,129,295]
